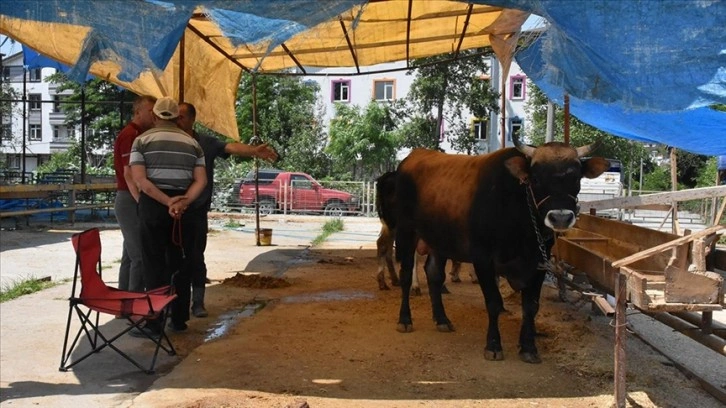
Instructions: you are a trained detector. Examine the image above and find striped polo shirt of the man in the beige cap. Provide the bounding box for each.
[129,122,204,191]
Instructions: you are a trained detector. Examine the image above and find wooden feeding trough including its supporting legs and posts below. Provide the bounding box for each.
[552,214,726,407]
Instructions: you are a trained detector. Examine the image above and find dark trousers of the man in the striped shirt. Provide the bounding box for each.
[139,190,202,323]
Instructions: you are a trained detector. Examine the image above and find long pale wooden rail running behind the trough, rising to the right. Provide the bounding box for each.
[580,186,726,213]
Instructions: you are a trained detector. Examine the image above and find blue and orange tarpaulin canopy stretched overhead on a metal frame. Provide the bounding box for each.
[0,0,726,155]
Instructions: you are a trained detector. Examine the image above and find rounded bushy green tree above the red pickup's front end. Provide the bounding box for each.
[326,101,400,180]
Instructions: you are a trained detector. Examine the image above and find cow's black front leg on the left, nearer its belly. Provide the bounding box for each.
[474,262,504,360]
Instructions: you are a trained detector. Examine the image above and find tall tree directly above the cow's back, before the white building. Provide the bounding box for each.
[404,49,499,154]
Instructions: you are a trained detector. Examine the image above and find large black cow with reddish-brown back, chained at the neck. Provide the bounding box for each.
[395,137,609,363]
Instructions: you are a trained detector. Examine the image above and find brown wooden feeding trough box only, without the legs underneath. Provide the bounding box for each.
[553,214,726,313]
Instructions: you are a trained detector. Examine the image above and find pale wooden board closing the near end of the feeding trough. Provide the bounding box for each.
[665,266,723,304]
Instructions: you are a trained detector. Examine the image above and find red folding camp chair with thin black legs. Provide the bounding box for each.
[59,228,176,374]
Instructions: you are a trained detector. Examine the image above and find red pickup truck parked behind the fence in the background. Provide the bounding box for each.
[239,169,360,217]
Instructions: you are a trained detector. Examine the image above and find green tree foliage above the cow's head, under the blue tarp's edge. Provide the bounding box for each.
[525,82,652,187]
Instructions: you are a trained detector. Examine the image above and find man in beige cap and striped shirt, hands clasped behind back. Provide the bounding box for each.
[130,97,207,334]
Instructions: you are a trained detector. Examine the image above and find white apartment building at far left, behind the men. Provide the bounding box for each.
[0,51,75,178]
